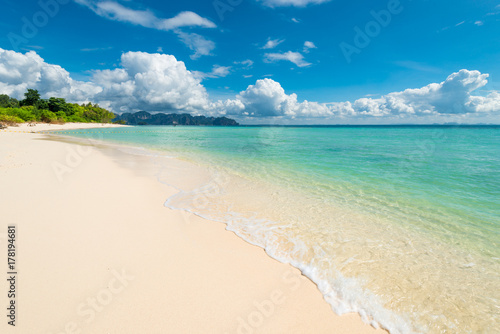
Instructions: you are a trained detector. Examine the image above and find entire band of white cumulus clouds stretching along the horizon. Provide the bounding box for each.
[0,49,500,123]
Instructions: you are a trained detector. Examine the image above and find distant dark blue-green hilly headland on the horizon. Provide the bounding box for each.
[113,111,239,126]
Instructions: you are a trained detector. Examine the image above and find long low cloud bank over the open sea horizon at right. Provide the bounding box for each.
[224,70,500,119]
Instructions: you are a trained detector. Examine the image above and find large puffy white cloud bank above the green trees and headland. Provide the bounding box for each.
[0,49,210,113]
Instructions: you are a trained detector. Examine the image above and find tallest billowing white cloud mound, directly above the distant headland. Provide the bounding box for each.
[92,52,209,113]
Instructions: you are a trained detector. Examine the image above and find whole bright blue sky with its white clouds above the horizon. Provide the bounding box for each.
[0,0,500,124]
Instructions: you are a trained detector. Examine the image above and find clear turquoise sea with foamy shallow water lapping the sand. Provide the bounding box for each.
[59,126,500,333]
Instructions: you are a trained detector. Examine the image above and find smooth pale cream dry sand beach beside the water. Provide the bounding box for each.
[0,125,385,334]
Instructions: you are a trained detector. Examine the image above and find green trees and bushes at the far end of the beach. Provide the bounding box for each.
[0,89,115,125]
